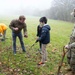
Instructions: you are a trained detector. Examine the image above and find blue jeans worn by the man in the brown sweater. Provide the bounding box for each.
[12,32,26,54]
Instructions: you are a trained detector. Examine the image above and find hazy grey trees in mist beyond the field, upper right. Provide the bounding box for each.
[47,0,75,21]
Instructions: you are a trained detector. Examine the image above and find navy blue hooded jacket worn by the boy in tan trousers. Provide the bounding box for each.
[38,24,51,44]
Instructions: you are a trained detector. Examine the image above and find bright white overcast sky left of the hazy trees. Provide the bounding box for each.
[0,0,52,14]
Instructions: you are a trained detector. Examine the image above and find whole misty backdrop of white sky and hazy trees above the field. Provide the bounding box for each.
[0,0,75,22]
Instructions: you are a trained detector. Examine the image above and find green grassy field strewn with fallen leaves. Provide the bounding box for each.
[0,17,73,75]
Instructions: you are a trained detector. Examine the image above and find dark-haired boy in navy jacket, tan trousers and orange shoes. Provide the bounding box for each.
[36,17,51,65]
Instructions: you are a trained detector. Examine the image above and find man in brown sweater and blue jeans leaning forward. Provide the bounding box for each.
[9,15,28,55]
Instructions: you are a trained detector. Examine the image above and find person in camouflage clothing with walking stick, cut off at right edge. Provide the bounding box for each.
[65,9,75,74]
